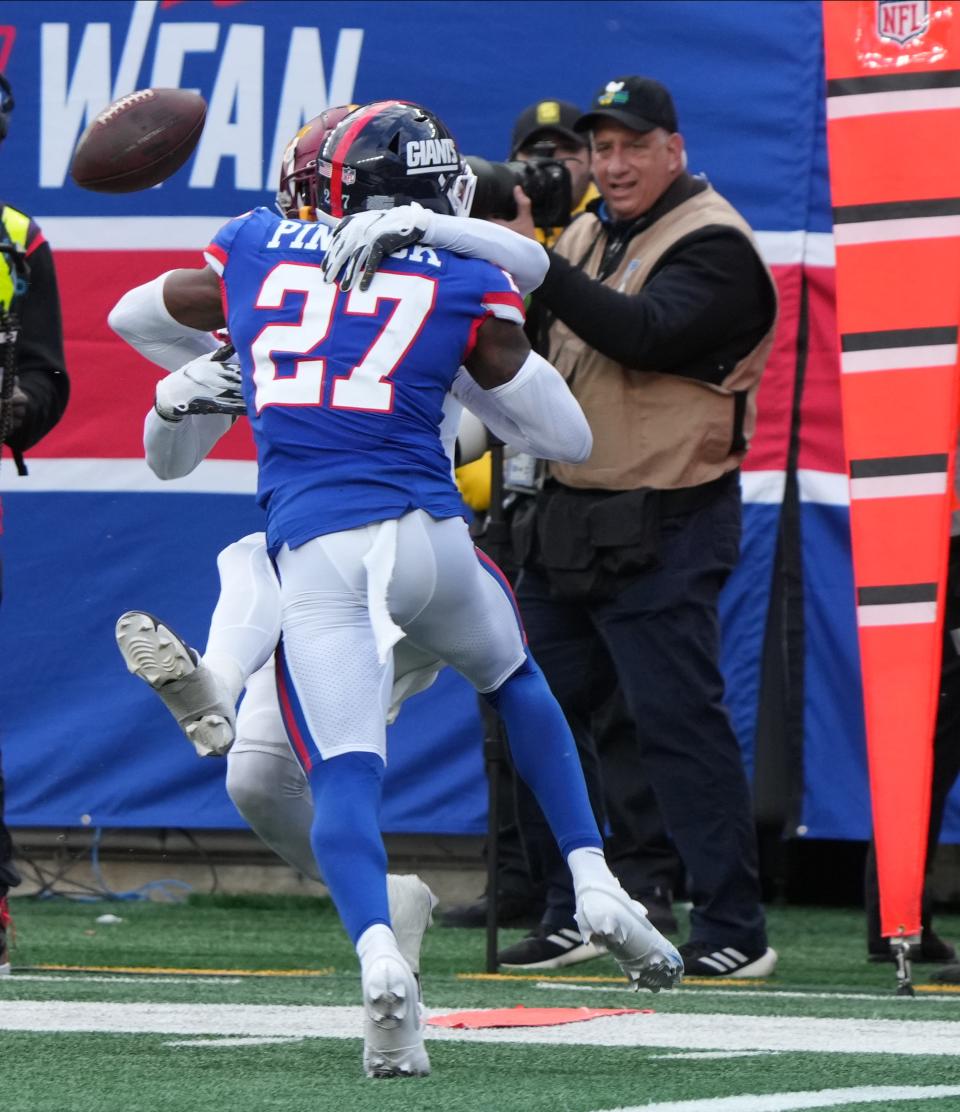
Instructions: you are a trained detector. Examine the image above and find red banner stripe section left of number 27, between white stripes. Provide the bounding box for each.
[36,250,256,459]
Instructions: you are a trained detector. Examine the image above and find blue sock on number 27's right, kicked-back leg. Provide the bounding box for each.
[484,653,603,857]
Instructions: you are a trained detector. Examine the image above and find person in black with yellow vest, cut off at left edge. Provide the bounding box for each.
[0,75,69,975]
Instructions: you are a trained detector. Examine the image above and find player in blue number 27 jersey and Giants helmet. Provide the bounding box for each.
[112,101,682,1075]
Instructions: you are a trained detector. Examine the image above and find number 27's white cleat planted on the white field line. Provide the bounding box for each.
[363,954,430,1078]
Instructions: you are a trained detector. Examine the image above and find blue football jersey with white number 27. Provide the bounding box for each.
[205,208,524,550]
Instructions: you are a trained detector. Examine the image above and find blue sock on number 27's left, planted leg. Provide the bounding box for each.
[310,753,390,944]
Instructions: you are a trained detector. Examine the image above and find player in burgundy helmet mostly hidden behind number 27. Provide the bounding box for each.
[110,108,552,920]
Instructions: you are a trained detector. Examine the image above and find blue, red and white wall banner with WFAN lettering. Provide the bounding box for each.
[0,0,956,837]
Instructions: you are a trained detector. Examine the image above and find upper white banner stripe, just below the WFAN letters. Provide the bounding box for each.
[34,216,833,267]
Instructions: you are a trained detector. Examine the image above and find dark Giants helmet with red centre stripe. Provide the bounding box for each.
[317,100,476,218]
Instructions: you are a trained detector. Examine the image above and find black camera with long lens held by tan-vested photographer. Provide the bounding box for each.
[466,155,573,228]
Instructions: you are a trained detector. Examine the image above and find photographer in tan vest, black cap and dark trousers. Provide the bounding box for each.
[491,77,776,976]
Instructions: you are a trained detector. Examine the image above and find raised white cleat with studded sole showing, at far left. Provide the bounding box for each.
[117,610,237,757]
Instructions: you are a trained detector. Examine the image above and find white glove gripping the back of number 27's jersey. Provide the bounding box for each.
[320,203,433,294]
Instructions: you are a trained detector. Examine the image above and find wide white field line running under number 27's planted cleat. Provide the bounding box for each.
[0,1000,960,1058]
